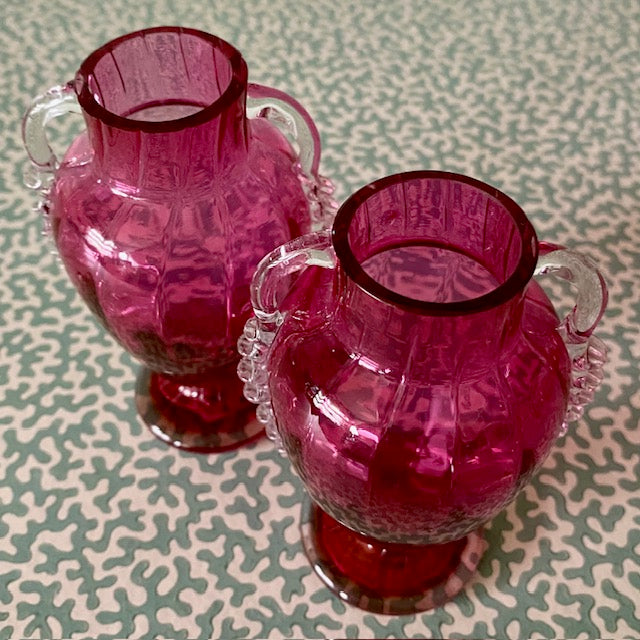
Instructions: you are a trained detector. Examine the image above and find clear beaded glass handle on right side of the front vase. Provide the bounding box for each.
[535,245,608,434]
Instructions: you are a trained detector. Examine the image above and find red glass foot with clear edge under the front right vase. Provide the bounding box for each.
[300,498,486,615]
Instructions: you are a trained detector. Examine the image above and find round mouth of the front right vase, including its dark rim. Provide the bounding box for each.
[332,170,538,315]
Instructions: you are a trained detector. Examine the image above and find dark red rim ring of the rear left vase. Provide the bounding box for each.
[71,26,248,133]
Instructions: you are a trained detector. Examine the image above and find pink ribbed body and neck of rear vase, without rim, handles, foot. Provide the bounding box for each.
[51,32,309,374]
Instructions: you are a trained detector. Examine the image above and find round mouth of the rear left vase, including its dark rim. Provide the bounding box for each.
[74,27,248,133]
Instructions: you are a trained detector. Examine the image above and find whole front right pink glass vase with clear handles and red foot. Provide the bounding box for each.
[238,171,607,613]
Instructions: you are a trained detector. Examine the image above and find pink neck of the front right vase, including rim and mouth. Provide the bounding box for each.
[324,171,537,379]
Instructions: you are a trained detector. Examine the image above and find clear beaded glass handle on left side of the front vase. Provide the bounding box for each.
[238,230,335,448]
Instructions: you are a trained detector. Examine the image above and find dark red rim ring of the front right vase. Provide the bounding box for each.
[331,169,539,316]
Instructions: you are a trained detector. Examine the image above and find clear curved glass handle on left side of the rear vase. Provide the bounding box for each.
[22,83,81,189]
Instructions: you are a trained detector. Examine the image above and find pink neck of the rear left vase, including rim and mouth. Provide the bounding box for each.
[75,27,247,191]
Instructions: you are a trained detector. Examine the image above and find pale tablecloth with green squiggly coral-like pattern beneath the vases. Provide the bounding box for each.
[0,0,640,638]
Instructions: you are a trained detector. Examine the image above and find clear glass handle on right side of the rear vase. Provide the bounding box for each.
[247,83,338,230]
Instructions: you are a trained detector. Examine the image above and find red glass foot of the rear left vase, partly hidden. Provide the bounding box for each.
[136,363,264,453]
